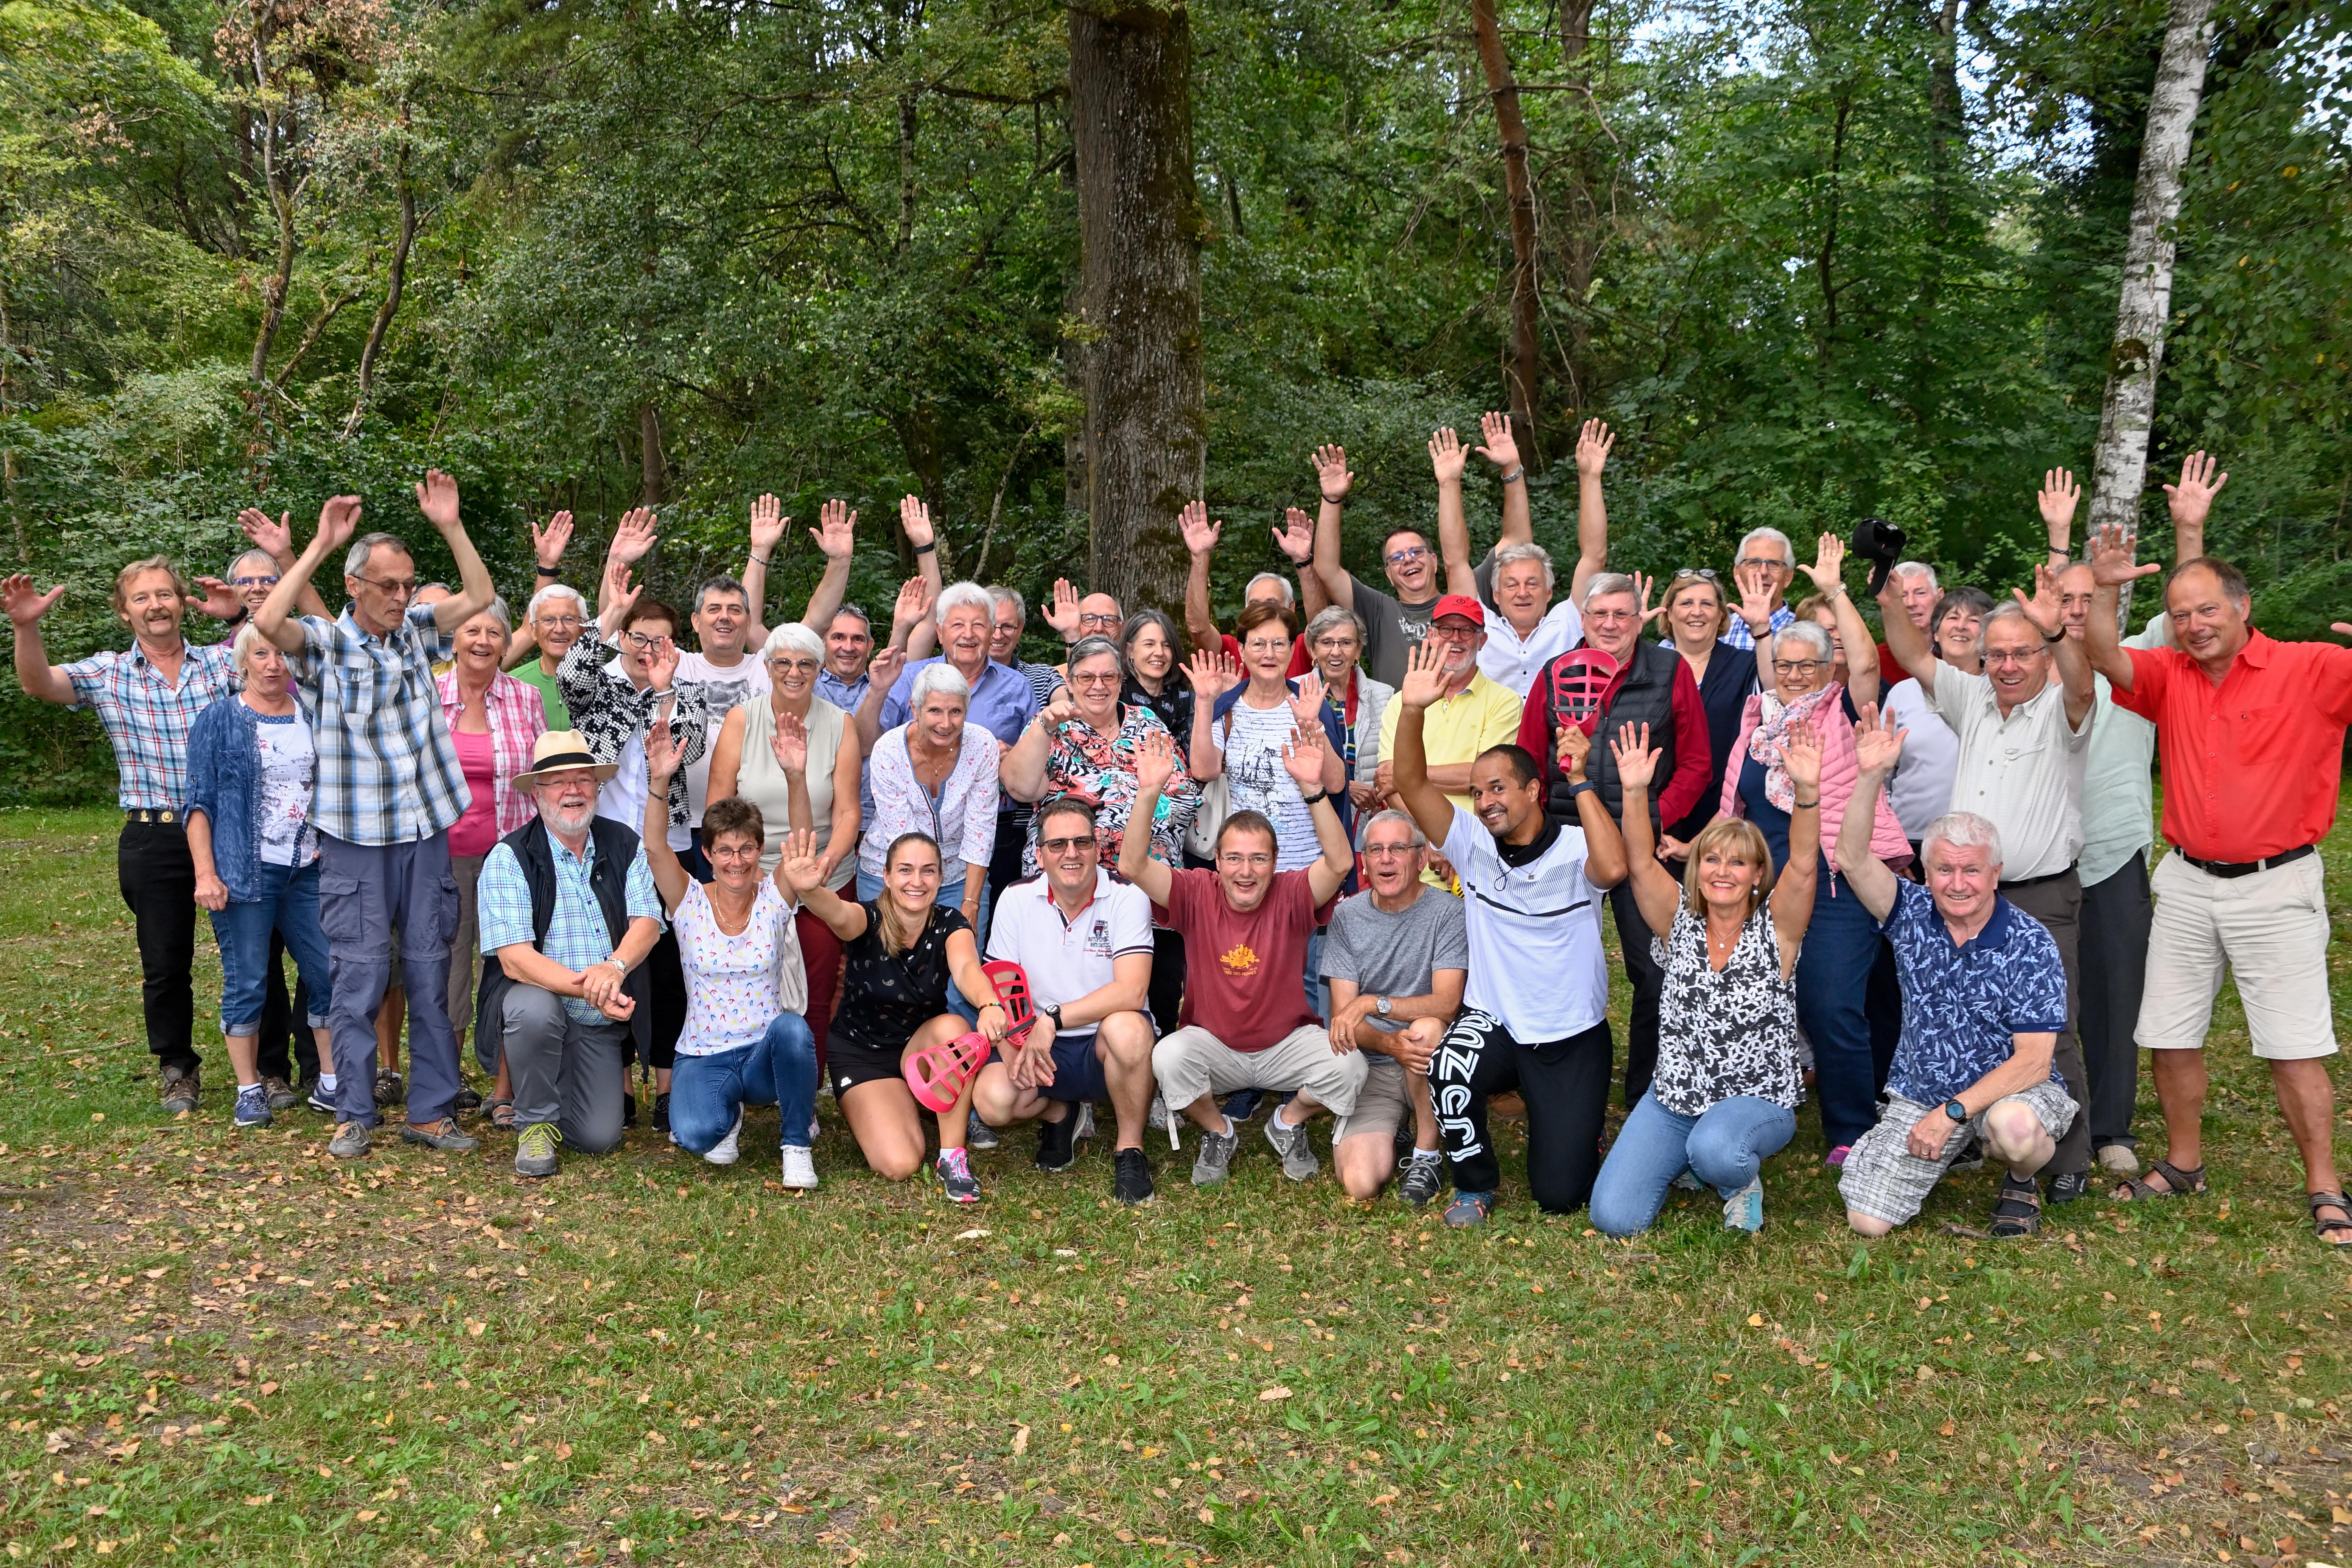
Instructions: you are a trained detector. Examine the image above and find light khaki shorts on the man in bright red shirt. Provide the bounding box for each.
[2133,853,2335,1063]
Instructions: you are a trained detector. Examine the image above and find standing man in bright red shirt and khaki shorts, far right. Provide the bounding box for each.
[2084,526,2352,1246]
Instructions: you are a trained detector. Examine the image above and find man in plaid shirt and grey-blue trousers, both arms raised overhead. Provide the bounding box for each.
[254,468,496,1159]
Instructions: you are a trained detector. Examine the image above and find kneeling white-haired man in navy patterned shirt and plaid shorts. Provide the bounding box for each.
[1837,705,2077,1237]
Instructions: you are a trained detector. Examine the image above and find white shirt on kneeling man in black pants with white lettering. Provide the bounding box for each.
[1444,806,1609,1046]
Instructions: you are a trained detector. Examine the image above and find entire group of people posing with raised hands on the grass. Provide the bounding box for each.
[0,416,2352,1246]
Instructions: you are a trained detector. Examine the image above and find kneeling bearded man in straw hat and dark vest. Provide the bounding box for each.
[475,729,661,1176]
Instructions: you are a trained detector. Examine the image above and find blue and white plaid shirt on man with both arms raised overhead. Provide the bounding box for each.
[287,604,473,844]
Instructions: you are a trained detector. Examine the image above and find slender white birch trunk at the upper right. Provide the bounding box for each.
[2091,0,2213,583]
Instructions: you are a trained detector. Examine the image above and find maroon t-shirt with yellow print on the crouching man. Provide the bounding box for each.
[1159,870,1322,1051]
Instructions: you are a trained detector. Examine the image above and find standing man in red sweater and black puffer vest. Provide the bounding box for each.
[1519,571,1722,1109]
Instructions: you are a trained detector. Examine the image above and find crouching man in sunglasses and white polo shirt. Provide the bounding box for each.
[972,797,1153,1204]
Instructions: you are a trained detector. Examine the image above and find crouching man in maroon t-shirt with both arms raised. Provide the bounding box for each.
[1120,722,1364,1187]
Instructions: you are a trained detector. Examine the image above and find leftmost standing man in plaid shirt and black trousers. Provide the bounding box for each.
[0,555,246,1112]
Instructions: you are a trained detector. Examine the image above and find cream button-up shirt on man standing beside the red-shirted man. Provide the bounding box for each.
[1926,661,2098,882]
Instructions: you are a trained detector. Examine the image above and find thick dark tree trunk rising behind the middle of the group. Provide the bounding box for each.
[1070,0,1209,613]
